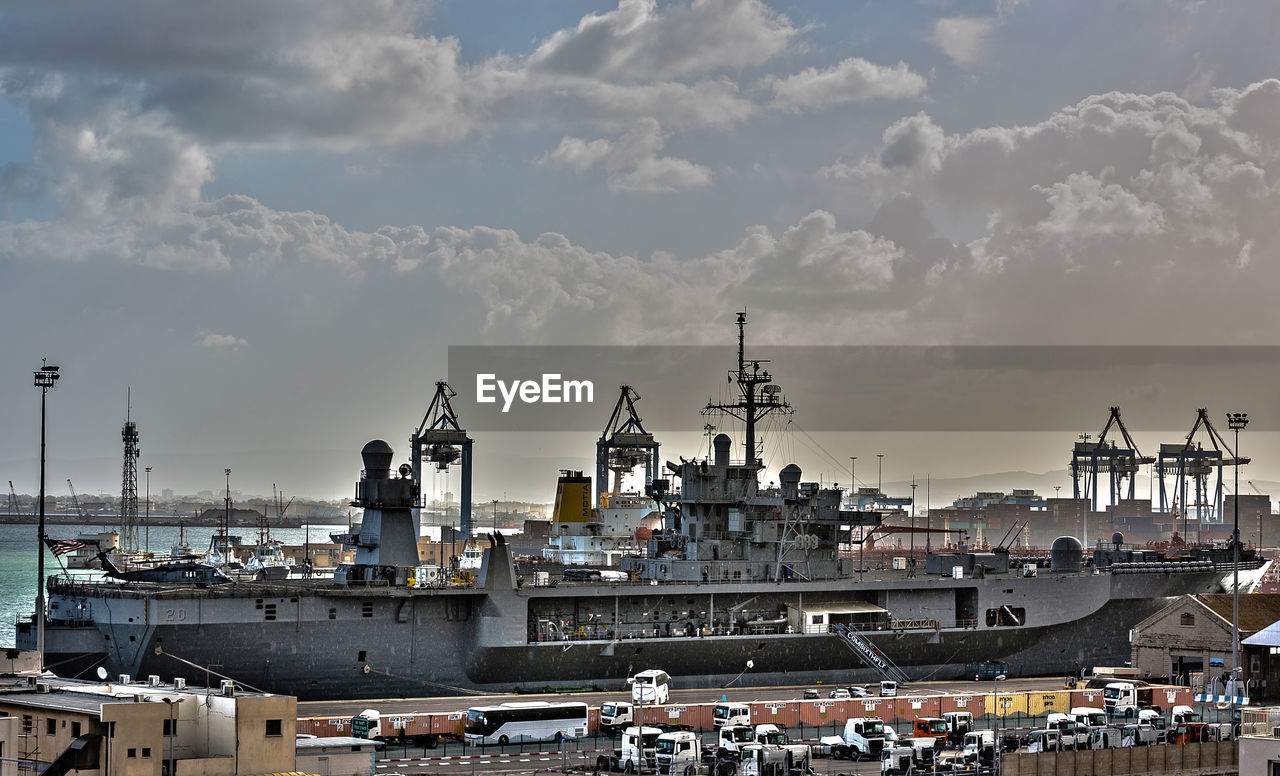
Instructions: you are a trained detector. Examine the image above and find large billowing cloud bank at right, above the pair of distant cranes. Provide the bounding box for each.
[824,79,1280,343]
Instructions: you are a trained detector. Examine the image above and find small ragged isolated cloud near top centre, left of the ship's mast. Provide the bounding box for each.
[538,118,712,192]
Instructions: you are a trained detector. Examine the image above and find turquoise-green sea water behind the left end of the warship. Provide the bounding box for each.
[0,525,347,647]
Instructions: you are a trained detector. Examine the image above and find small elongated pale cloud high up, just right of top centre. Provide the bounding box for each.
[760,58,927,113]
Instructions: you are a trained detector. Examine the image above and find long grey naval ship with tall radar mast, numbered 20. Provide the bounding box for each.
[17,314,1260,699]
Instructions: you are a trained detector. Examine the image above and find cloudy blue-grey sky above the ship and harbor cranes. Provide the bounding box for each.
[0,0,1280,501]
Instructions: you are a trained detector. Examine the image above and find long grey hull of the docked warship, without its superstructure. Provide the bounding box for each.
[19,555,1239,699]
